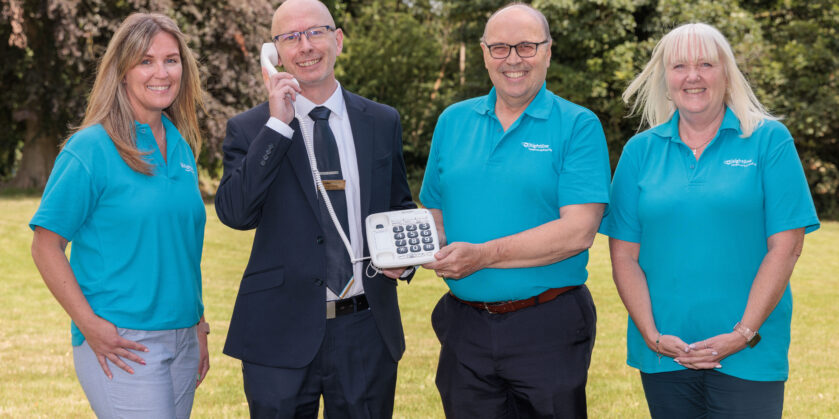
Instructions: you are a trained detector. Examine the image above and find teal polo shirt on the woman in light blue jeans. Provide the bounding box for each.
[30,116,206,346]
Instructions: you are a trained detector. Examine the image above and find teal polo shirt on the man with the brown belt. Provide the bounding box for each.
[420,84,610,302]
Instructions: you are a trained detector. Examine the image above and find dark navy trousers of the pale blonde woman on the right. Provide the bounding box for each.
[641,370,784,419]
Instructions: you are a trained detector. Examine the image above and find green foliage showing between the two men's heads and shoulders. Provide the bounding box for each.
[336,2,449,185]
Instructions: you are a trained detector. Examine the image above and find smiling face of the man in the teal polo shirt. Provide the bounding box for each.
[481,6,551,109]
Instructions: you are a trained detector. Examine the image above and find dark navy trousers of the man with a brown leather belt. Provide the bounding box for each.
[431,285,597,419]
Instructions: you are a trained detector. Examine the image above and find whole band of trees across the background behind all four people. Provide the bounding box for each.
[0,0,839,218]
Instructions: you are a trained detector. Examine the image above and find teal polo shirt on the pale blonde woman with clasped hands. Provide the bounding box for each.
[600,109,819,381]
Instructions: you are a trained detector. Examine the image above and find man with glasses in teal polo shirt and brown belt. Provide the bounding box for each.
[420,4,610,418]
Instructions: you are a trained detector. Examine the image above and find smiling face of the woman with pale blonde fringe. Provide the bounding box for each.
[664,43,728,118]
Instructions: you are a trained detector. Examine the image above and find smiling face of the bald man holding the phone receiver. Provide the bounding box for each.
[271,0,344,91]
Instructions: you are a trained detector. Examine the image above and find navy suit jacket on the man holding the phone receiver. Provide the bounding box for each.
[216,90,416,368]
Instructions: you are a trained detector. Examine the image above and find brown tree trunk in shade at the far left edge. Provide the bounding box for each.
[9,116,59,189]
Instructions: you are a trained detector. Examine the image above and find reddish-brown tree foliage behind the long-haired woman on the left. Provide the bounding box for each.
[0,0,273,187]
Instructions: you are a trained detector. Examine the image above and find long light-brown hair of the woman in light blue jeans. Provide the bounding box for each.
[67,13,204,175]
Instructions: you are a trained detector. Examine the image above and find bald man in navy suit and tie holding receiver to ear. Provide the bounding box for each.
[216,0,415,418]
